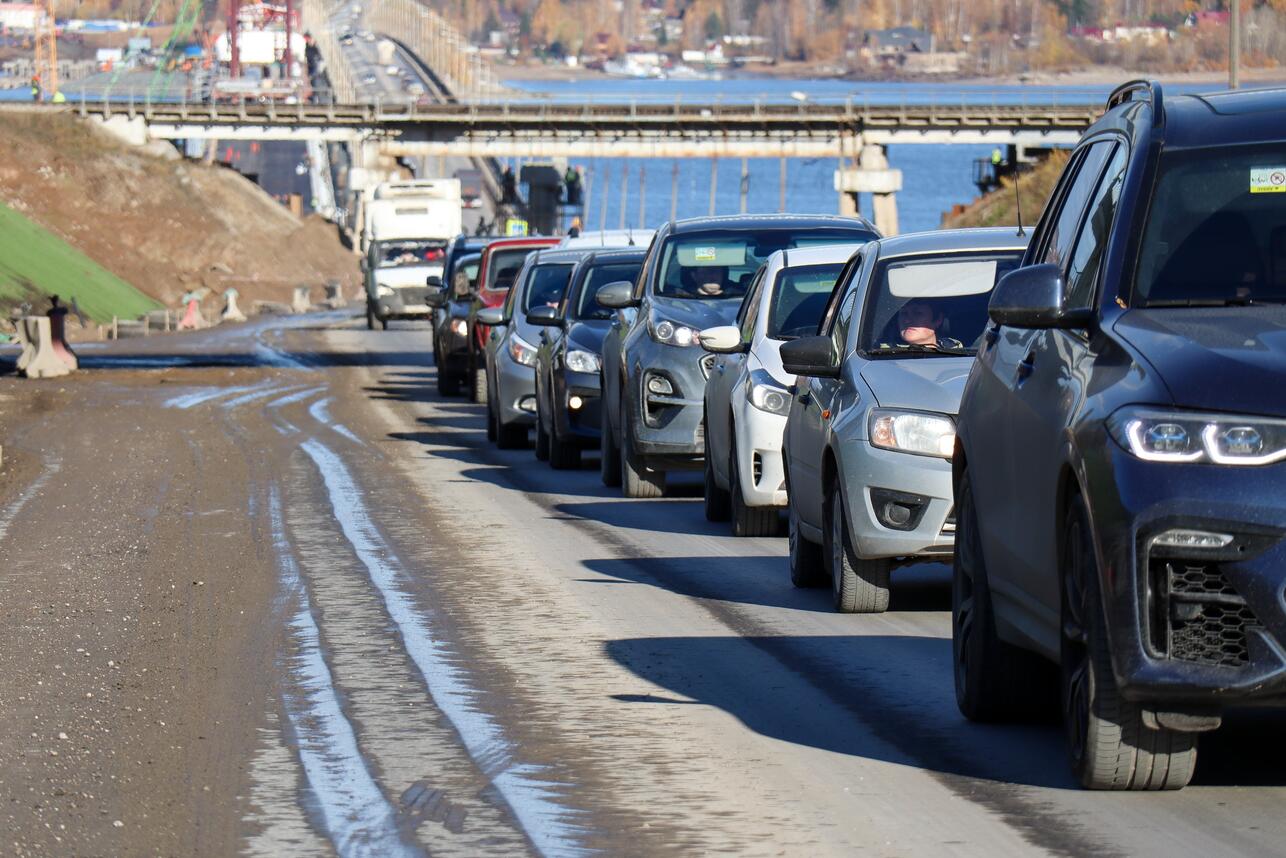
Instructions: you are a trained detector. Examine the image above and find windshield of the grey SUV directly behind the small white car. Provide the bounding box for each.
[655,226,873,300]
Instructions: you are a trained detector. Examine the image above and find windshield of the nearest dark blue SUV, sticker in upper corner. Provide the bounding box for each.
[1133,144,1286,307]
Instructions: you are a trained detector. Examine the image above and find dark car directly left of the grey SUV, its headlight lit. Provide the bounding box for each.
[527,248,643,470]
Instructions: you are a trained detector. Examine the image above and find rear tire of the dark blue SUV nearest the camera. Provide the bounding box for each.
[952,471,1055,723]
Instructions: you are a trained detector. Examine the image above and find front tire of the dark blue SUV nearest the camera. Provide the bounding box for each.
[1058,495,1197,790]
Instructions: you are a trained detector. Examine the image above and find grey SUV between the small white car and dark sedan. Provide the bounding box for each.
[598,215,880,498]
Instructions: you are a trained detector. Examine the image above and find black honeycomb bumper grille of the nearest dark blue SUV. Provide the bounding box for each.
[1148,560,1259,668]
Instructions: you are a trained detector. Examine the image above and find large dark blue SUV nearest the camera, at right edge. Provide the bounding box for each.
[952,81,1286,790]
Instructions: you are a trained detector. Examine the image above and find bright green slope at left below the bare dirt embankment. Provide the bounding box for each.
[0,203,161,322]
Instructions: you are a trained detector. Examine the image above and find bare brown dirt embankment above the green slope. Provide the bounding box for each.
[0,112,360,310]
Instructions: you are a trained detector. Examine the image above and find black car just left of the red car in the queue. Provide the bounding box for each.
[428,235,495,396]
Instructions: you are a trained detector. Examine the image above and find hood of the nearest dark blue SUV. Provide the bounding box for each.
[1112,305,1286,414]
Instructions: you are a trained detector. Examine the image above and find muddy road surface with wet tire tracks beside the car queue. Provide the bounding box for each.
[0,313,1286,855]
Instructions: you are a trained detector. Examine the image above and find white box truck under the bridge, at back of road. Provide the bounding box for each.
[363,179,463,329]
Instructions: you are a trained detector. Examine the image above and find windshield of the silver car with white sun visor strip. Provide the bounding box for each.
[858,250,1022,355]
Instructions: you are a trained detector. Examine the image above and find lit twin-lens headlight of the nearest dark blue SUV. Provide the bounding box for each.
[1107,405,1286,466]
